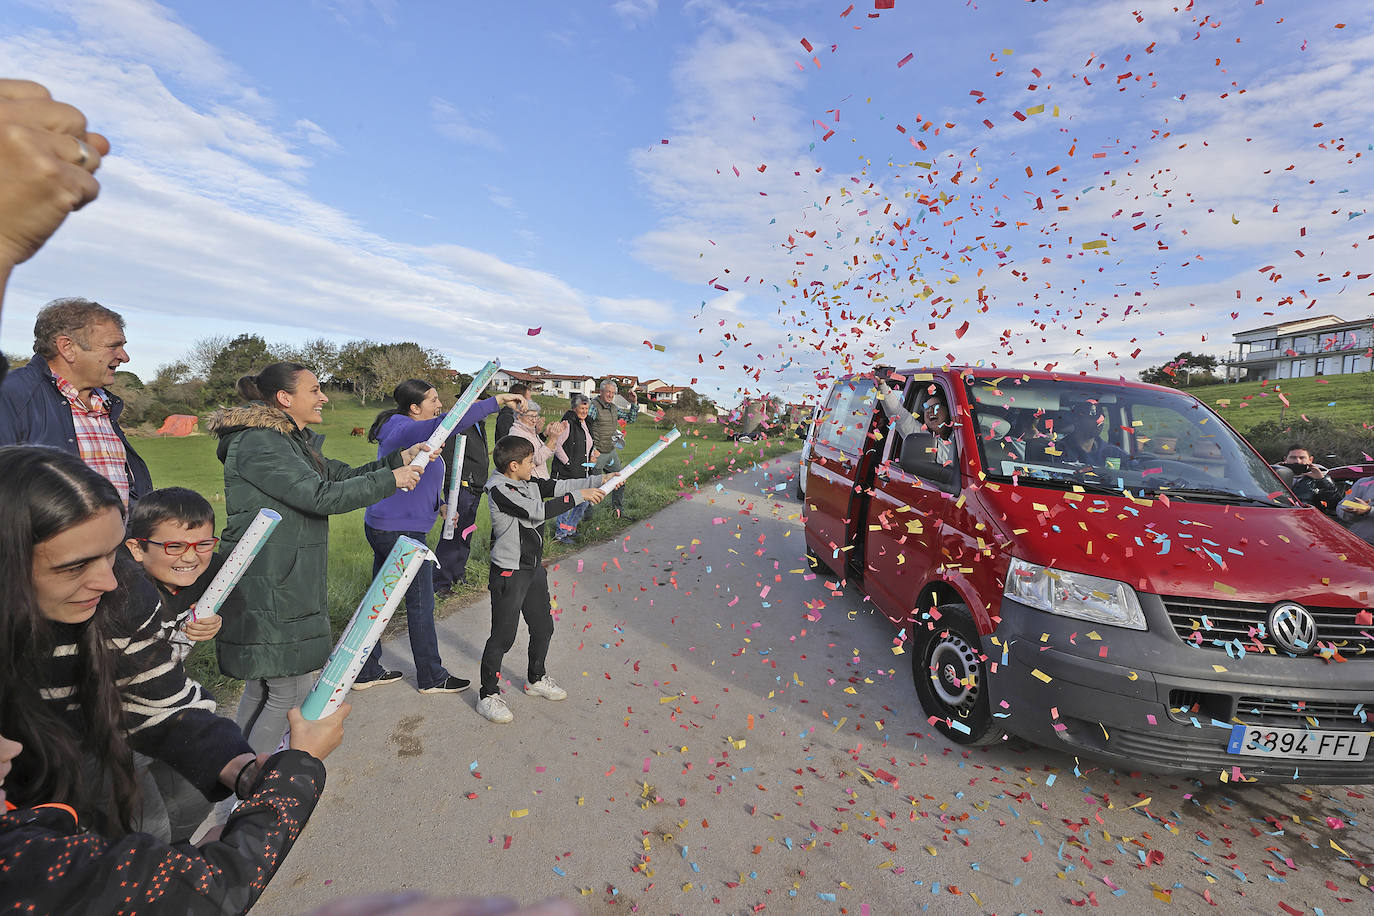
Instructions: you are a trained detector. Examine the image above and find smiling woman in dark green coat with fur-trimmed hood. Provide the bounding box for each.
[206,363,426,753]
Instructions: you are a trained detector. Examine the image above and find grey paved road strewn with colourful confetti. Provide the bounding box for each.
[257,456,1374,913]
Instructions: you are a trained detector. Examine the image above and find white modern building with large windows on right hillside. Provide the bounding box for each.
[1221,314,1374,382]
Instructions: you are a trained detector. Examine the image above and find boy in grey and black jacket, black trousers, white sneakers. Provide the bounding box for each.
[477,435,618,724]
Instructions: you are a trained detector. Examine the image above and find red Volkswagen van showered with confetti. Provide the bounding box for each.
[805,368,1374,784]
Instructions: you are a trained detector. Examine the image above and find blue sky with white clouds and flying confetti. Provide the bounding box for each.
[0,0,1374,404]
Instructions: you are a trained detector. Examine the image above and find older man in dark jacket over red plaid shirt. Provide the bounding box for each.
[0,299,153,503]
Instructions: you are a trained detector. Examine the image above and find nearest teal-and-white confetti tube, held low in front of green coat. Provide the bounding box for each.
[287,536,434,750]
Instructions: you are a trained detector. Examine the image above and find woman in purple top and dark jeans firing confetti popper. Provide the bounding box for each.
[353,379,525,694]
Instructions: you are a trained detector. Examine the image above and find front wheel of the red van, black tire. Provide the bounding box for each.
[911,604,1006,747]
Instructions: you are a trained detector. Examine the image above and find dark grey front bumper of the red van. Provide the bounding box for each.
[982,593,1374,784]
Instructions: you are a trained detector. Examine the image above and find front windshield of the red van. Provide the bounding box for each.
[965,376,1297,507]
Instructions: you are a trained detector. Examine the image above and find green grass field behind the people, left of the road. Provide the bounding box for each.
[133,394,801,702]
